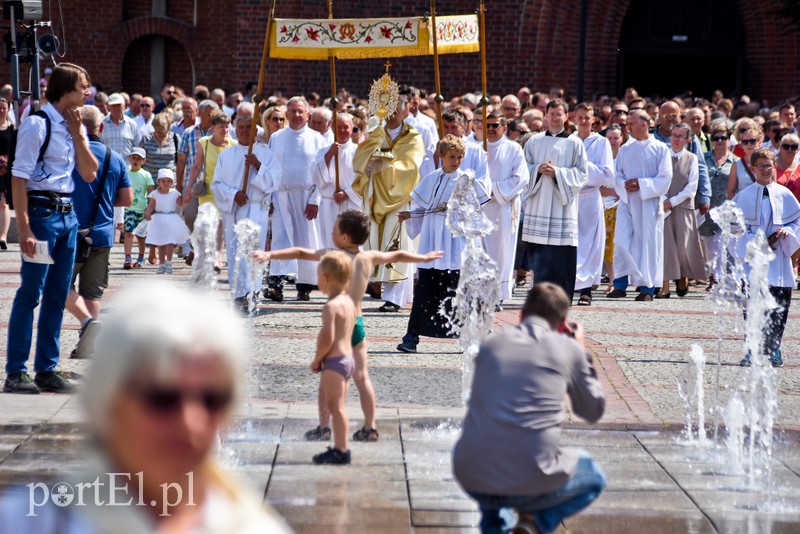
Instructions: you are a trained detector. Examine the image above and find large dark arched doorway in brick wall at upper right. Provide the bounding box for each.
[617,0,745,98]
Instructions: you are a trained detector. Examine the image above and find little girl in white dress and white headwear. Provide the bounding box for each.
[144,169,189,274]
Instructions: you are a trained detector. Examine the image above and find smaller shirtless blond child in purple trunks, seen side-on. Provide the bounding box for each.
[311,250,356,464]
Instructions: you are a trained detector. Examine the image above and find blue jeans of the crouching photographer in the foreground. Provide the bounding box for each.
[469,450,606,534]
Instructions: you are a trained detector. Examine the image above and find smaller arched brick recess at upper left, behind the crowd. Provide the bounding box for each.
[122,35,195,96]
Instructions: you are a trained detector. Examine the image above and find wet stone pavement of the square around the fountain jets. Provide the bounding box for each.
[0,245,800,534]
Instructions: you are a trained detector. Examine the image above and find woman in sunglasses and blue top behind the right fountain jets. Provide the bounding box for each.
[697,120,736,291]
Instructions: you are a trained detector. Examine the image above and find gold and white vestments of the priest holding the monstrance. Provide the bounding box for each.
[353,122,425,282]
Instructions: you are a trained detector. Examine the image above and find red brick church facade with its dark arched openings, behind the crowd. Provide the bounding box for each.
[45,0,800,103]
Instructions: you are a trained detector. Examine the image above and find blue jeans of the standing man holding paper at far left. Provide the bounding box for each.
[6,204,78,374]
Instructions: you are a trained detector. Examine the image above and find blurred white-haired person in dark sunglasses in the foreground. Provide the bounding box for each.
[0,284,290,534]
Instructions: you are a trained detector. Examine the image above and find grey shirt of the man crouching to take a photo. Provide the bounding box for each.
[453,317,605,496]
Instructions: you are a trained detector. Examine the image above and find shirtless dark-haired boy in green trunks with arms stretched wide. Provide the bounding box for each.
[253,210,442,441]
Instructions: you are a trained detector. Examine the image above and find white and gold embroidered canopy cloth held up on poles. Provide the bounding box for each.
[270,15,480,60]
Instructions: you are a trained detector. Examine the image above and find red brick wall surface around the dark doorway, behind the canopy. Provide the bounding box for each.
[32,0,800,104]
